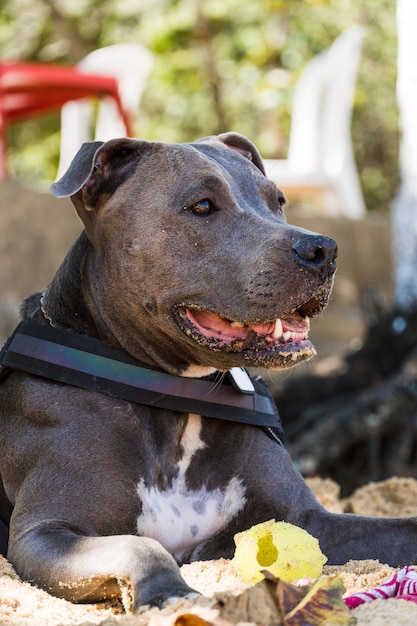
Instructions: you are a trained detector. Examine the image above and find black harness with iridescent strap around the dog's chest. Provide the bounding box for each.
[0,322,284,553]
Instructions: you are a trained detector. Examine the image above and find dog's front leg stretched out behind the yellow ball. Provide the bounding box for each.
[193,433,417,567]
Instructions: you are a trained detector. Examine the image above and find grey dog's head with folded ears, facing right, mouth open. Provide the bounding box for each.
[52,133,337,374]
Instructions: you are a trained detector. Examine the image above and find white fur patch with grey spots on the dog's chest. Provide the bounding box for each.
[137,414,246,560]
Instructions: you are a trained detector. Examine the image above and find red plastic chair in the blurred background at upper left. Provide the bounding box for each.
[0,62,133,180]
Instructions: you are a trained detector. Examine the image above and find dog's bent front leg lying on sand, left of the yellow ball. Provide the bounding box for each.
[8,524,196,611]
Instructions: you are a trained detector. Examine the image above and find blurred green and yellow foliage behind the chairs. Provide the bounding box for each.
[0,0,398,210]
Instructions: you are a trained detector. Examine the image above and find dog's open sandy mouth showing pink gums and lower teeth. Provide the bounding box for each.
[176,306,316,368]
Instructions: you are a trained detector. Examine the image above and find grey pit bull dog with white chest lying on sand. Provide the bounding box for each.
[0,133,417,609]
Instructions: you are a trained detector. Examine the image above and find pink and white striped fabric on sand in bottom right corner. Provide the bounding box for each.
[345,565,417,609]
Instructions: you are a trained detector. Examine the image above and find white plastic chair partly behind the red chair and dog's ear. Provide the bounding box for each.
[58,44,153,178]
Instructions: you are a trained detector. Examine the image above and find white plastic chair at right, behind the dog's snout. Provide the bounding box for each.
[264,26,366,219]
